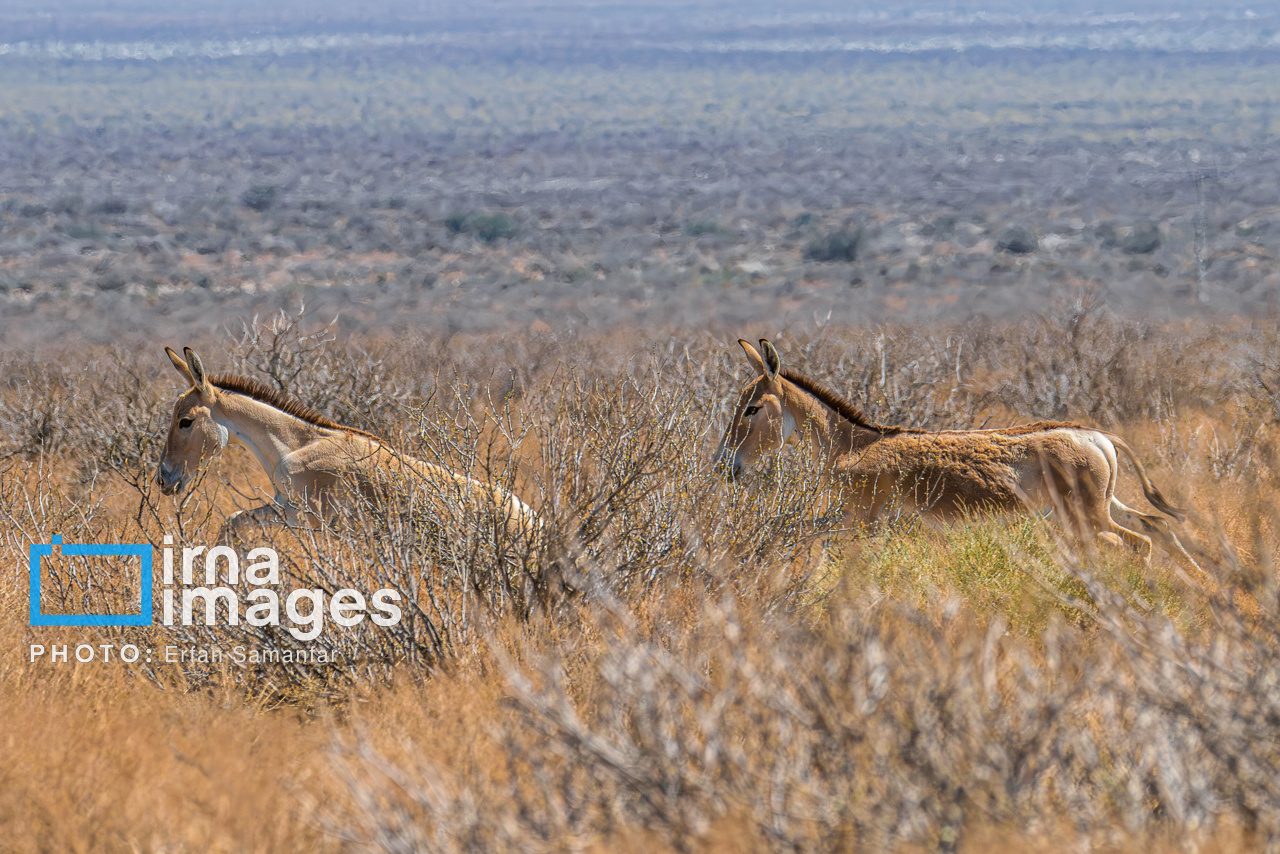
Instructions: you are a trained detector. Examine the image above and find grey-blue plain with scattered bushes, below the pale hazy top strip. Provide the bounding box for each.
[0,32,1280,332]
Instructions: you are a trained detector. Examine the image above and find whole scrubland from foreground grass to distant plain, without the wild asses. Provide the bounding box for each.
[0,0,1280,851]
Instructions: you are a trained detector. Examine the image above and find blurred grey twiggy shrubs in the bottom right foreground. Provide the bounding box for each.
[332,547,1280,851]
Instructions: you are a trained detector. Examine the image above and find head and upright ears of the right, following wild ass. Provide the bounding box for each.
[716,338,796,480]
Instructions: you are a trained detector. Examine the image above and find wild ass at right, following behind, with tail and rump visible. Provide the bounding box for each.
[717,338,1199,570]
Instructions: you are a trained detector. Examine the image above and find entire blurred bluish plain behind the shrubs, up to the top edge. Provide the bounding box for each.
[0,0,1280,348]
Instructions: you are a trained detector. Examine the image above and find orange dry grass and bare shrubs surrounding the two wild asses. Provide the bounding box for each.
[0,306,1280,851]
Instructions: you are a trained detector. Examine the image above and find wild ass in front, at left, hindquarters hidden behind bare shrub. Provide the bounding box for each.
[156,347,536,536]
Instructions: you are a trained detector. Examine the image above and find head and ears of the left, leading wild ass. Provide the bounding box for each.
[156,347,230,495]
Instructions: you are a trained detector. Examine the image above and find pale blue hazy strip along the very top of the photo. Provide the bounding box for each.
[0,0,1280,60]
